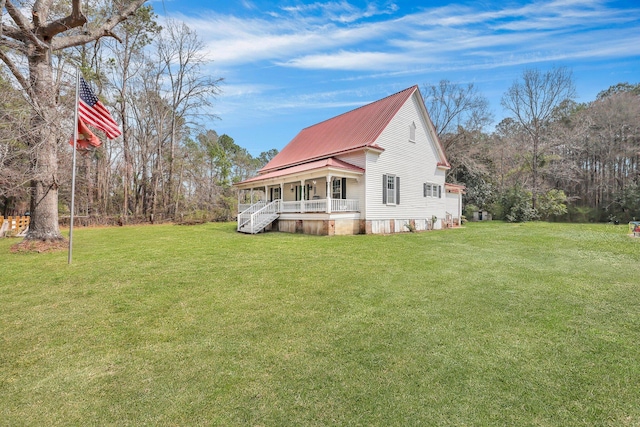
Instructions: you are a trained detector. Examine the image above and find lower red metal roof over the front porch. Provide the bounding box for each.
[234,157,364,189]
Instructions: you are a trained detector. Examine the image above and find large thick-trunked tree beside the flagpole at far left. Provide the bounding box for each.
[0,0,145,241]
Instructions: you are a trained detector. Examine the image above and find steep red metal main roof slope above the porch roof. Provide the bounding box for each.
[260,86,418,173]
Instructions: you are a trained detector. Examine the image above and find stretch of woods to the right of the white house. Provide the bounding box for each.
[422,71,640,222]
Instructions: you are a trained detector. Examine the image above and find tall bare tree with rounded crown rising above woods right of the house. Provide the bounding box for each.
[501,67,576,209]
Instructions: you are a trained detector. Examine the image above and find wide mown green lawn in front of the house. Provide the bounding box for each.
[0,222,640,426]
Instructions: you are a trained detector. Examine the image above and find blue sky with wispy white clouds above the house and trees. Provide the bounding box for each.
[151,0,640,156]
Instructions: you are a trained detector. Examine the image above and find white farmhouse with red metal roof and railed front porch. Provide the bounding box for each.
[235,86,464,235]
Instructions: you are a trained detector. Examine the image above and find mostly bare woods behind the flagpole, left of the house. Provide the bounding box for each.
[0,0,277,240]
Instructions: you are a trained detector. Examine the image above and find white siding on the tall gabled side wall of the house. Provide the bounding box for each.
[362,94,446,222]
